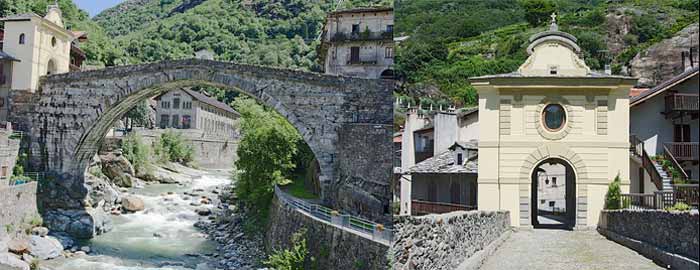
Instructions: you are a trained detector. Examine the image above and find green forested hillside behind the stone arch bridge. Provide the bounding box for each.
[94,0,392,70]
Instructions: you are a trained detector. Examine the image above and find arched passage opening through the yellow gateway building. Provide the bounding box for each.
[530,158,576,229]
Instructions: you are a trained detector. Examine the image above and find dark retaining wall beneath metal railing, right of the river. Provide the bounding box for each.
[265,195,389,270]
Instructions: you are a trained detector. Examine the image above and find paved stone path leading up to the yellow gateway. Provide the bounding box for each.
[481,229,664,270]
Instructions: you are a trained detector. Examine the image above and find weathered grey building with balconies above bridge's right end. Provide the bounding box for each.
[318,7,394,79]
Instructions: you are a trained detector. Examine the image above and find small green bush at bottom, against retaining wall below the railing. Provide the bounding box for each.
[264,229,309,270]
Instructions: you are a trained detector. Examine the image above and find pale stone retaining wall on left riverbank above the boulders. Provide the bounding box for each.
[0,182,39,239]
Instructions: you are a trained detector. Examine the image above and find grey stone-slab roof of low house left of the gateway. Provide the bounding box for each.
[406,150,479,174]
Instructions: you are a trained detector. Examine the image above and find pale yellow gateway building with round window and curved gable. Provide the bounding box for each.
[470,15,636,228]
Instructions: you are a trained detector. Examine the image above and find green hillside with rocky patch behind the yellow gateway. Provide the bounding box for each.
[396,0,698,106]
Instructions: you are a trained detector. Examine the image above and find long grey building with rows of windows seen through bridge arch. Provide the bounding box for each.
[154,89,240,138]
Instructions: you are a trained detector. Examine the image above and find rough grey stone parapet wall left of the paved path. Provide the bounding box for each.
[391,211,511,270]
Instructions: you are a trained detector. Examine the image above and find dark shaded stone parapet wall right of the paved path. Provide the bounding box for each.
[598,210,700,269]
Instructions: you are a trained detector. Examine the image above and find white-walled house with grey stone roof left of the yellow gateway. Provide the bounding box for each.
[395,108,479,215]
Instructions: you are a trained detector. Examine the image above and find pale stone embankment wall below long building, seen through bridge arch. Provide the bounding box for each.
[136,129,240,169]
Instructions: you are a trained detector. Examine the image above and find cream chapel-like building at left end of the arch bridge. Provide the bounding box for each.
[0,5,87,122]
